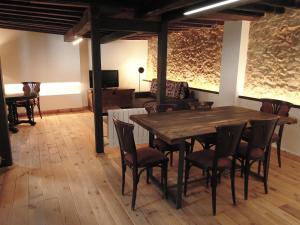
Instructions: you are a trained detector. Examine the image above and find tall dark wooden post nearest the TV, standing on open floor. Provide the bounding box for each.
[91,7,104,153]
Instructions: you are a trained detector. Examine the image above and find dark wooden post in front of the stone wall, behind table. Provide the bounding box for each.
[156,21,168,104]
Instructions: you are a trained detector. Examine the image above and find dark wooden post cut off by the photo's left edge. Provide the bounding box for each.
[0,61,12,167]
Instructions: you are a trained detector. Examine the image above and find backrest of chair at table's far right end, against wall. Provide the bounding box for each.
[260,98,293,116]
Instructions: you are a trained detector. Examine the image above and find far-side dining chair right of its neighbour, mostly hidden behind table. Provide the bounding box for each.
[189,101,216,152]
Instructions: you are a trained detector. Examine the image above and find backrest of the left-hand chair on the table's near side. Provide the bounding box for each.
[215,122,247,158]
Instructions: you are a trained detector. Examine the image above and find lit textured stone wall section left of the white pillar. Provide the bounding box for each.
[147,26,223,91]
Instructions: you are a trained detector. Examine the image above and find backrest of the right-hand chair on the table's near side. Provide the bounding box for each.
[248,118,278,152]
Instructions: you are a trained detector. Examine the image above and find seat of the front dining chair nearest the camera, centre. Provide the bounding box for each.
[186,149,231,169]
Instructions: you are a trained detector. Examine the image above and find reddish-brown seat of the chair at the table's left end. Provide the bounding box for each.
[125,147,168,167]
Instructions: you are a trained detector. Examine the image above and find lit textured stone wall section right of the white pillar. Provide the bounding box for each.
[243,10,300,105]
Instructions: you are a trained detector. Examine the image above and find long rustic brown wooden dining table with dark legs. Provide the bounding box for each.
[130,106,297,209]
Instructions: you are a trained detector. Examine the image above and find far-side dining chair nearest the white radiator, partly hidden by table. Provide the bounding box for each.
[145,104,190,166]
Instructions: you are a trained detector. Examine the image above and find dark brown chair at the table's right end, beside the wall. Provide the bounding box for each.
[260,98,293,168]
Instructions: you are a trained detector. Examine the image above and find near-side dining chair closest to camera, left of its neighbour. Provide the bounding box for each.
[184,123,246,215]
